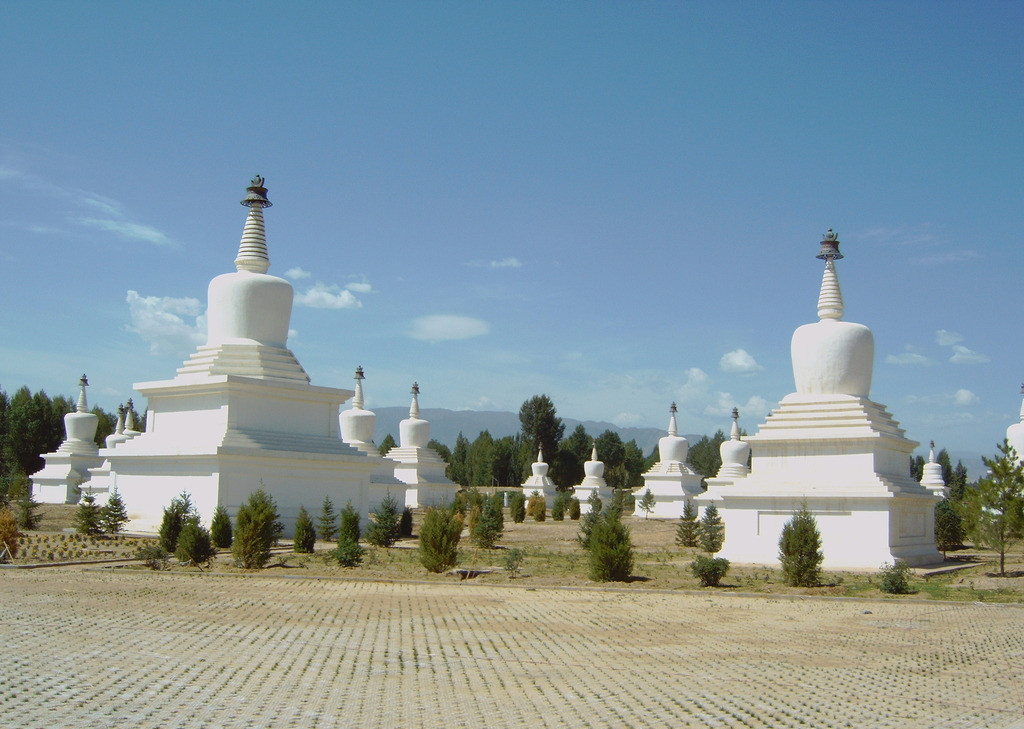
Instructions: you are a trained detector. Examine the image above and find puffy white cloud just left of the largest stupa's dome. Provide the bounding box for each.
[125,291,206,354]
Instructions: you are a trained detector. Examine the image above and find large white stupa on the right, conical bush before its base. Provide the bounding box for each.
[696,230,942,569]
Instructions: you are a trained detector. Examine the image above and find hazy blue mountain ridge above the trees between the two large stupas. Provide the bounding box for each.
[374,408,711,456]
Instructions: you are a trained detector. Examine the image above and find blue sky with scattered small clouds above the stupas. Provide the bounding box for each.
[0,2,1024,454]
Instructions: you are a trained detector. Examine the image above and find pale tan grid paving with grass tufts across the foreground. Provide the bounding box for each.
[0,569,1024,729]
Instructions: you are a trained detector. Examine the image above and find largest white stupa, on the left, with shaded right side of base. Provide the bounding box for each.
[82,175,381,534]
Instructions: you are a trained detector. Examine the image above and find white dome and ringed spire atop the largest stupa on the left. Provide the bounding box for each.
[207,175,294,349]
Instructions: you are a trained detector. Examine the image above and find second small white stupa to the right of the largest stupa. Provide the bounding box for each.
[385,382,459,509]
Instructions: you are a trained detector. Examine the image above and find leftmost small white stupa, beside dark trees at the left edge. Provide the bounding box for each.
[32,375,103,504]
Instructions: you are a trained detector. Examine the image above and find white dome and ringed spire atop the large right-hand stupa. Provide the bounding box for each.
[791,229,874,398]
